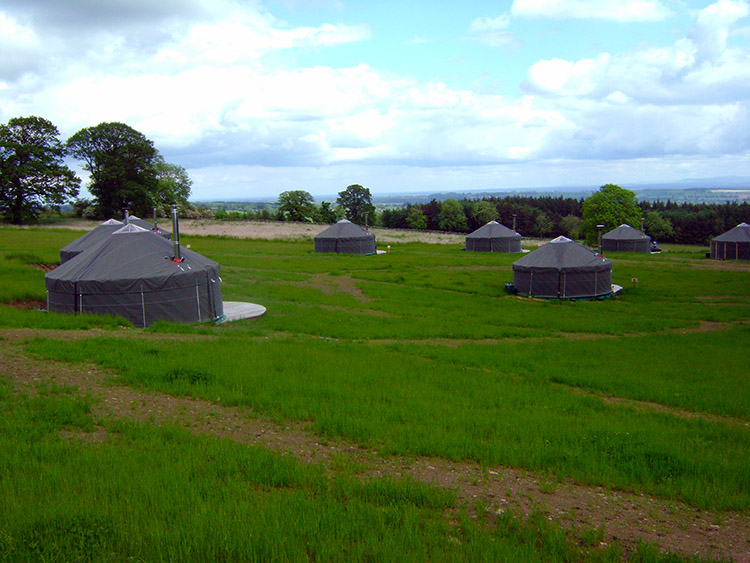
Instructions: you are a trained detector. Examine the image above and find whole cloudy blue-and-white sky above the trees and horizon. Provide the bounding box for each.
[0,0,750,201]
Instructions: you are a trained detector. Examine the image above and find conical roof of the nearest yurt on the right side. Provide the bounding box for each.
[513,236,612,271]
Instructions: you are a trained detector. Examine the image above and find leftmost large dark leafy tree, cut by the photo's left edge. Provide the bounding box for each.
[0,116,81,224]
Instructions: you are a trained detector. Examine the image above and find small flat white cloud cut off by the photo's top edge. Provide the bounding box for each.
[510,0,671,22]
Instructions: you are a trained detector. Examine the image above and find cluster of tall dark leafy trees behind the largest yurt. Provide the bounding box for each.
[0,116,192,224]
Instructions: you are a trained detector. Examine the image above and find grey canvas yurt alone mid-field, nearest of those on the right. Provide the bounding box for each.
[513,237,612,299]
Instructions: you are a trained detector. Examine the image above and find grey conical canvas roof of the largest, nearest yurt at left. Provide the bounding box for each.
[45,224,219,290]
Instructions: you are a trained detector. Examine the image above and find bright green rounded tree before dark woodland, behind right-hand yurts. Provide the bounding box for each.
[580,184,641,245]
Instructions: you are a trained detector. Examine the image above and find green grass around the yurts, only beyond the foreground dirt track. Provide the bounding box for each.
[0,229,750,555]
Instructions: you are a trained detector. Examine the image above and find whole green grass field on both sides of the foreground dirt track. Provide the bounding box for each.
[0,228,750,561]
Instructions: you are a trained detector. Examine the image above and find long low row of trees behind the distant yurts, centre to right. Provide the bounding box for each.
[268,184,750,245]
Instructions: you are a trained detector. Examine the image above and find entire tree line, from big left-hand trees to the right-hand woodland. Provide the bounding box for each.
[0,116,750,244]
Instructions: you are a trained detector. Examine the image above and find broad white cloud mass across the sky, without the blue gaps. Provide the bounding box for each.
[0,0,750,199]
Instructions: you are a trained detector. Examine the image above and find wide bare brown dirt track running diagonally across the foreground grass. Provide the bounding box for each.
[0,330,750,562]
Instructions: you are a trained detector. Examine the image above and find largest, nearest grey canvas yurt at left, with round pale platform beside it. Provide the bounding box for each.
[45,225,223,328]
